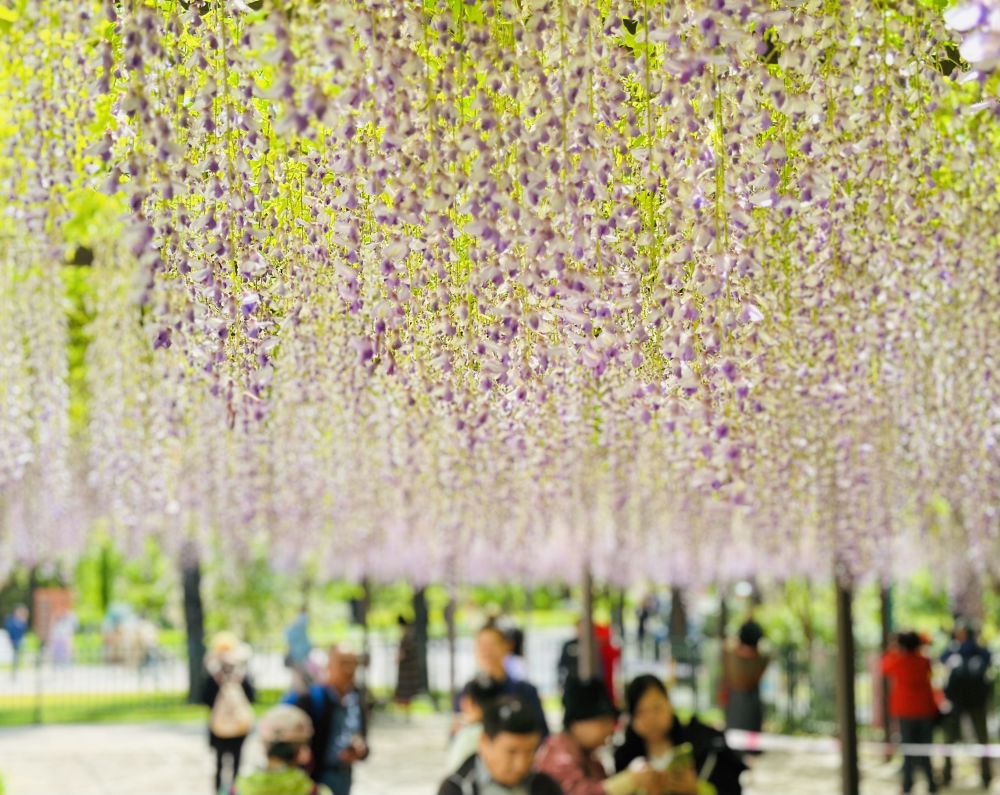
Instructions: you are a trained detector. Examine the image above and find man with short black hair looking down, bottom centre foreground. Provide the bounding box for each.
[438,696,562,795]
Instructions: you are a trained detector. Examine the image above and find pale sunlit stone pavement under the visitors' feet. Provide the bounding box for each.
[0,716,1000,795]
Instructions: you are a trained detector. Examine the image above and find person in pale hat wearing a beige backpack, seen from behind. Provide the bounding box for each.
[201,632,256,792]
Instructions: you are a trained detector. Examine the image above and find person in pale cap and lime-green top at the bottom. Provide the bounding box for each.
[231,704,331,795]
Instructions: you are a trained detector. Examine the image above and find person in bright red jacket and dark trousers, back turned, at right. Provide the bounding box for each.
[882,632,938,793]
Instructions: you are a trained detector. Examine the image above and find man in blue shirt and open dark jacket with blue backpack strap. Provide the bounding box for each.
[282,646,368,795]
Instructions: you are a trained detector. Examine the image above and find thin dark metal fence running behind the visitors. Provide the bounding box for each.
[0,630,878,731]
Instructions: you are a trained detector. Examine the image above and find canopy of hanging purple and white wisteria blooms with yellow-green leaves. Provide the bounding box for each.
[0,0,1000,582]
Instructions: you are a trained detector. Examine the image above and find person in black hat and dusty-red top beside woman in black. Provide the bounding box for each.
[535,677,661,795]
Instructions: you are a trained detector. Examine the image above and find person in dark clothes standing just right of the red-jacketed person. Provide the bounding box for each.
[941,624,993,790]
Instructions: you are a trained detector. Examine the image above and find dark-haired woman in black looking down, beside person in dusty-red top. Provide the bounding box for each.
[615,674,746,795]
